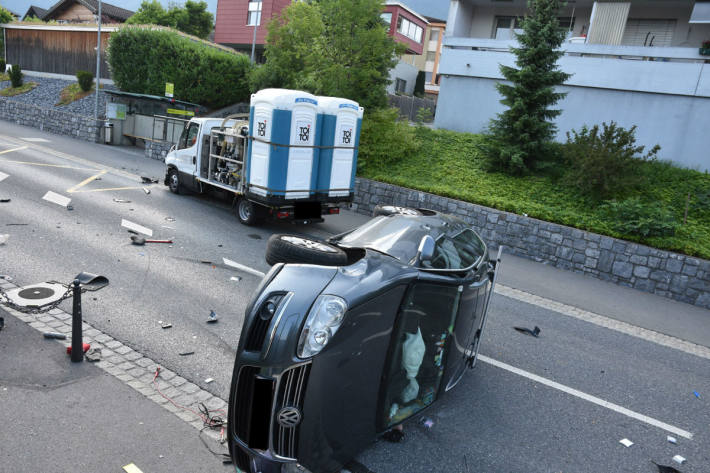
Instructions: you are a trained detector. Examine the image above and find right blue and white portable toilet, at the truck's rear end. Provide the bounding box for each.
[318,97,363,197]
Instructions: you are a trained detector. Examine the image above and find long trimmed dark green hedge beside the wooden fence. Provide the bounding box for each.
[107,27,251,108]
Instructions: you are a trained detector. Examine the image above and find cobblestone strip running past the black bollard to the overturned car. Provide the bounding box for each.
[0,280,227,440]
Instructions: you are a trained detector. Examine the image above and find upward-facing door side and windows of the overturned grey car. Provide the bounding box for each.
[336,214,486,270]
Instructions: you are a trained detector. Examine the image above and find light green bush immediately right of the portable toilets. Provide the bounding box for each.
[358,108,419,171]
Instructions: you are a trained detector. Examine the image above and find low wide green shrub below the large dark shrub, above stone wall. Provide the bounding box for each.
[601,197,678,238]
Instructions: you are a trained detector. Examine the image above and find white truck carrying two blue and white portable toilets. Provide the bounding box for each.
[164,89,362,229]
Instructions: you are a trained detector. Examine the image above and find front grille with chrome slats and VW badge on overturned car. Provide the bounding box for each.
[272,363,311,460]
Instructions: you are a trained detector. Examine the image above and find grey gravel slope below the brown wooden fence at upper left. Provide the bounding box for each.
[0,75,118,117]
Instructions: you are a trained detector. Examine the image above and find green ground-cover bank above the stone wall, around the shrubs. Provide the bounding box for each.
[358,128,710,259]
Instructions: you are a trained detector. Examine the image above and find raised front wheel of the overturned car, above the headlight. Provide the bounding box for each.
[266,235,348,266]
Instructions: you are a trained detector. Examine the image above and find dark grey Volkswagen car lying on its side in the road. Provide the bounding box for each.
[228,207,500,473]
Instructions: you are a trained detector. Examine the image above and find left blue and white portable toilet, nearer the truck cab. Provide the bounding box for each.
[246,89,320,200]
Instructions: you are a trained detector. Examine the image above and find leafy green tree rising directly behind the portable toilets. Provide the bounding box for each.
[252,0,405,110]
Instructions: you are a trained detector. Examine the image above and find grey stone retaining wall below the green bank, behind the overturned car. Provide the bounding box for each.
[353,178,710,309]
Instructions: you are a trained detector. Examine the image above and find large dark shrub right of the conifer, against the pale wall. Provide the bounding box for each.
[562,121,661,200]
